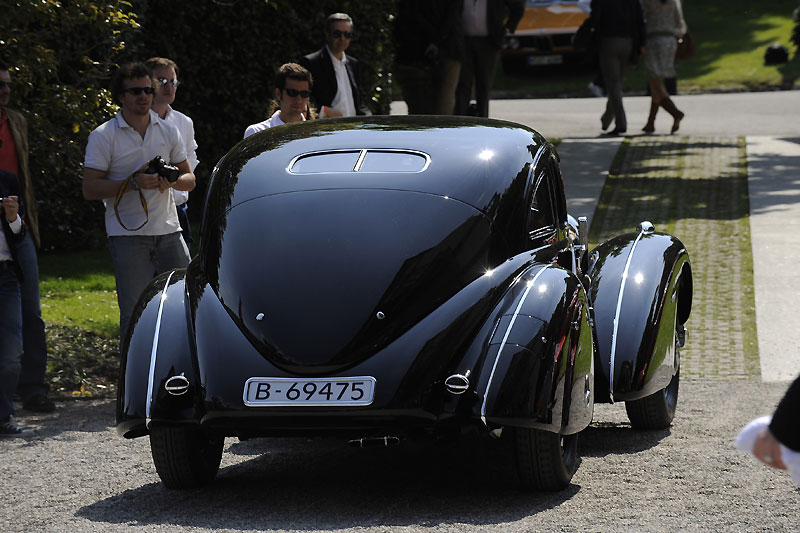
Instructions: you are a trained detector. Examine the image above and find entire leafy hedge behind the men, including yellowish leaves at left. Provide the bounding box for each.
[0,0,395,251]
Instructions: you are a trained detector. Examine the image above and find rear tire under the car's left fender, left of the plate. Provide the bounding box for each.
[150,426,225,489]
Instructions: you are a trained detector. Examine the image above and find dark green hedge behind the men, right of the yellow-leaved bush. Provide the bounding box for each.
[133,0,395,216]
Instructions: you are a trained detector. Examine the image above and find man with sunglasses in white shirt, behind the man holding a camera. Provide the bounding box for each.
[145,57,199,246]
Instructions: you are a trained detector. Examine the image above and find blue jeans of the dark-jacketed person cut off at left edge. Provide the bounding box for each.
[0,270,22,420]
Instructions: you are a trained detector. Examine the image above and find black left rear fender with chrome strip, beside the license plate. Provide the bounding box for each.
[117,270,201,438]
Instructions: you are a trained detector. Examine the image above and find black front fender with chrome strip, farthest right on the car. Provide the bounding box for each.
[588,223,692,401]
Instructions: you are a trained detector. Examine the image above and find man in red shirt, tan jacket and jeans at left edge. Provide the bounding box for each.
[0,62,56,413]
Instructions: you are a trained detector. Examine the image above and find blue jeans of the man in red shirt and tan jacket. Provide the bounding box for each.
[16,232,50,402]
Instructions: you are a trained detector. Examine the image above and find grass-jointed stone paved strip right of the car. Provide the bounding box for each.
[590,136,761,379]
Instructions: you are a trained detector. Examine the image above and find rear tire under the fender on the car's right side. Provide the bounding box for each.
[512,428,580,491]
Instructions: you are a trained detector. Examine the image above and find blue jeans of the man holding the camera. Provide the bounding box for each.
[108,232,189,340]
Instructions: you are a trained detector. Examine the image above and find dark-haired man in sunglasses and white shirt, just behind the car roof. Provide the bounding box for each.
[244,63,313,137]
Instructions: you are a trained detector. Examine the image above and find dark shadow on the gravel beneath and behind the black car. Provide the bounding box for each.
[77,439,580,530]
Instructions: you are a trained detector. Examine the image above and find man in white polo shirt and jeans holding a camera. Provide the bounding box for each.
[83,63,195,347]
